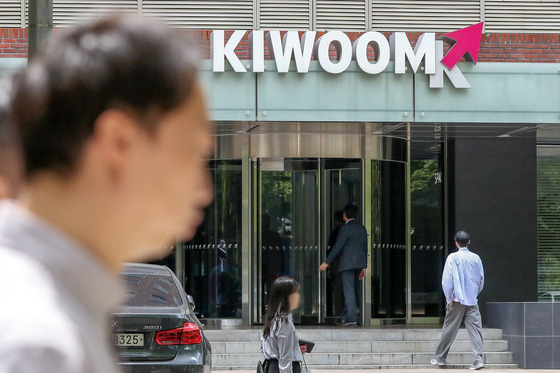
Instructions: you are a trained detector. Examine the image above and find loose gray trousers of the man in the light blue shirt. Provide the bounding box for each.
[436,302,483,364]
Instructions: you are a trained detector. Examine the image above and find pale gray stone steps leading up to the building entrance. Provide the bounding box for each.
[204,327,517,370]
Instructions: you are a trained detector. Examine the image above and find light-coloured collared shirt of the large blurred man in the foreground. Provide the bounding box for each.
[0,201,124,373]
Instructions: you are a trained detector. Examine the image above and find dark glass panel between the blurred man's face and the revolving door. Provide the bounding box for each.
[178,160,242,318]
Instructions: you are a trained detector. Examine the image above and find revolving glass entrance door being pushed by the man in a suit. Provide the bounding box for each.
[253,158,362,324]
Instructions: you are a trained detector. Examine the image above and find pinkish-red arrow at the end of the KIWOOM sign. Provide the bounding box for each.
[440,22,484,69]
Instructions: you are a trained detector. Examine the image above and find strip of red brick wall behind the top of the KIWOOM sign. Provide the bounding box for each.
[0,28,560,63]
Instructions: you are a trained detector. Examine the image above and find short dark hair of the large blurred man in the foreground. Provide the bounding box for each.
[13,15,198,176]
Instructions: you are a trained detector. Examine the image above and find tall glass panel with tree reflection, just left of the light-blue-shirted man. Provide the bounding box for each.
[410,143,445,317]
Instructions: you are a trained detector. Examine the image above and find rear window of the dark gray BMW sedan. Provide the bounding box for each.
[122,273,183,307]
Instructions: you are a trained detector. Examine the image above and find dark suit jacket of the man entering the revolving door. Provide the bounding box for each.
[325,220,368,272]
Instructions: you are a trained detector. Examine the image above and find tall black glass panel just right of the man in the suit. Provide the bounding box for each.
[371,161,406,318]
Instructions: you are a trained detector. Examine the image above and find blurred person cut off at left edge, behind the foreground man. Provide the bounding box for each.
[0,76,22,199]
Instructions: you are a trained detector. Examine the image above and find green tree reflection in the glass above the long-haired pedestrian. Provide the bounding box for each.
[262,171,292,234]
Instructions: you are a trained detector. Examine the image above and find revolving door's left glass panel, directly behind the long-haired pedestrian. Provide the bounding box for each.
[257,159,319,323]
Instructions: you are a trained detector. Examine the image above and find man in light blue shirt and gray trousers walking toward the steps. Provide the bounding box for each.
[431,231,484,370]
